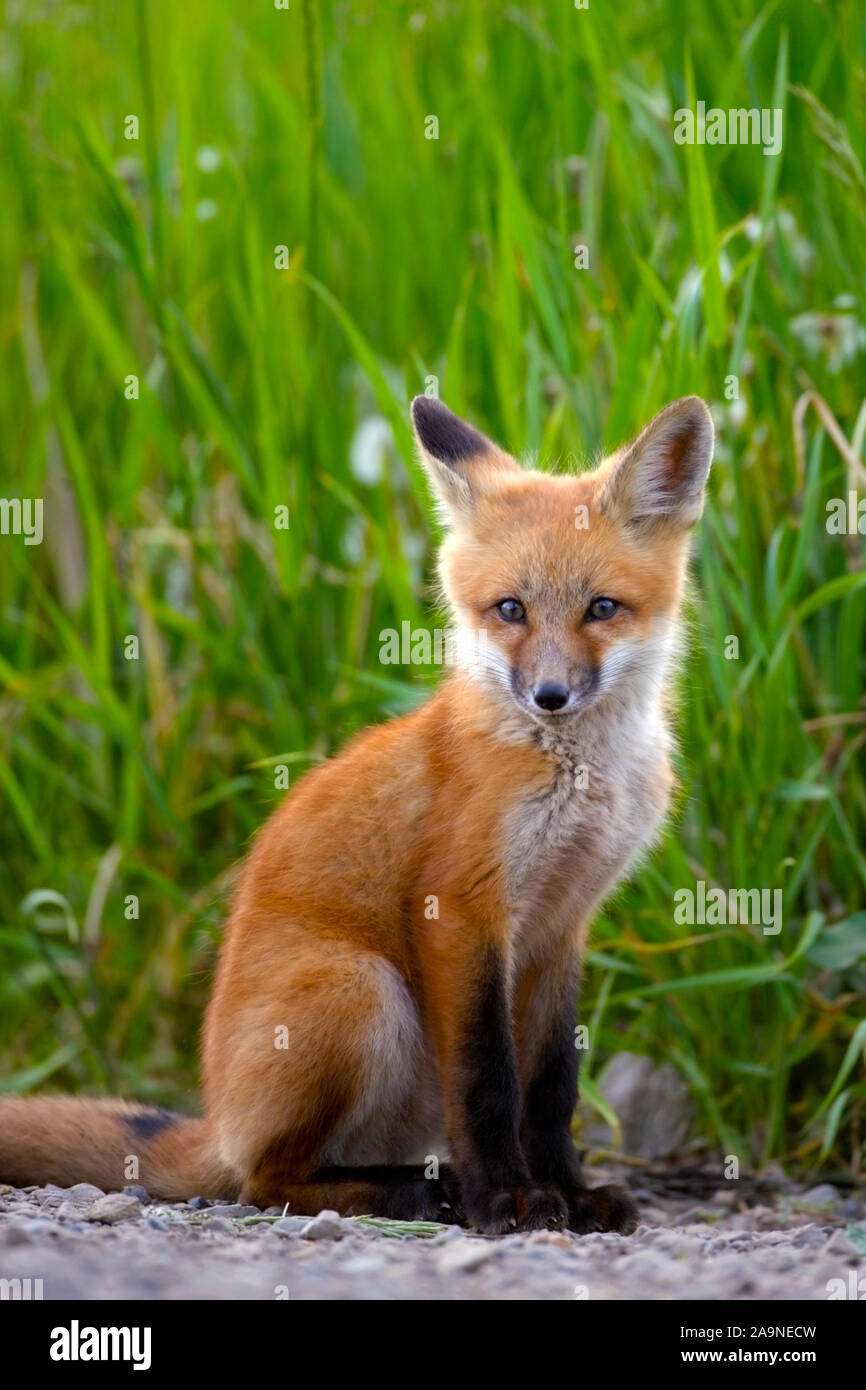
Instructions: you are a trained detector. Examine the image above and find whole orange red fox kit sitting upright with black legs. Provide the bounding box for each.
[0,396,713,1233]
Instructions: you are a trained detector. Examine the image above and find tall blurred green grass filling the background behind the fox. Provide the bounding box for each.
[0,0,866,1170]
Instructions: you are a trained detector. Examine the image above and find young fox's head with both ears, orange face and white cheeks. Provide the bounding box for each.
[411,396,713,728]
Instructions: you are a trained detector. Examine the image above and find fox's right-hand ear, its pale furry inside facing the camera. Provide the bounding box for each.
[601,396,713,528]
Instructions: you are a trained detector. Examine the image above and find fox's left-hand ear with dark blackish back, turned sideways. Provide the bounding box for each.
[411,396,520,525]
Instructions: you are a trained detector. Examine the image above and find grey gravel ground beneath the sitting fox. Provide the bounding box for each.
[0,1172,866,1300]
